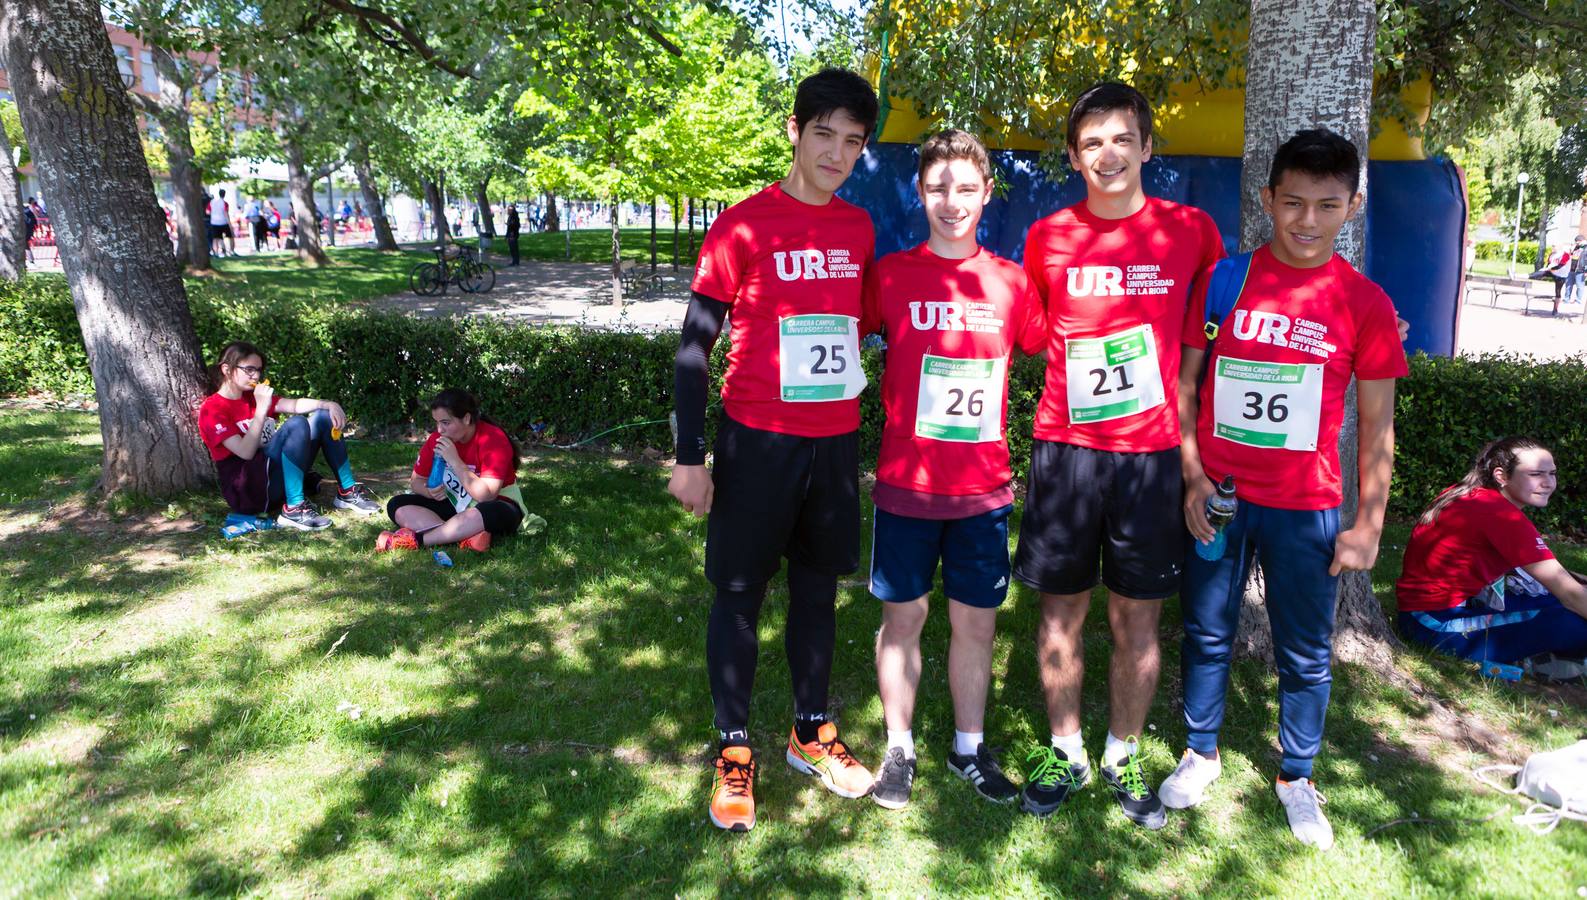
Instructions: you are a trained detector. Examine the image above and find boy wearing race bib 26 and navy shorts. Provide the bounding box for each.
[868,130,1047,810]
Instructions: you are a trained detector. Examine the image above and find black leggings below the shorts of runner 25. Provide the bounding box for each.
[705,560,838,732]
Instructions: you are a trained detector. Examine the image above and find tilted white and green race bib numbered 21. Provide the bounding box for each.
[1065,324,1163,425]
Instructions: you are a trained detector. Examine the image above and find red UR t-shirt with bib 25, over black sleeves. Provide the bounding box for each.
[692,184,876,438]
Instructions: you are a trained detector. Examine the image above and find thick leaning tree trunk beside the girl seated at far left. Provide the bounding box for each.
[0,0,214,495]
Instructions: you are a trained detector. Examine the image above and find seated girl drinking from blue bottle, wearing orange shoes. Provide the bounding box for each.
[375,387,524,552]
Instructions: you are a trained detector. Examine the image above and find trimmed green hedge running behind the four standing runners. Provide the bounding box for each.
[0,276,1587,532]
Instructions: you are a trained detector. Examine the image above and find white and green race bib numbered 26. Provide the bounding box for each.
[914,354,1008,444]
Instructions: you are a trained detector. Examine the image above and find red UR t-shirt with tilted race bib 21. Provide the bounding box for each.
[1025,197,1224,452]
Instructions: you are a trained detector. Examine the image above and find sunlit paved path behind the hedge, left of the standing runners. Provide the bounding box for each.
[370,259,694,332]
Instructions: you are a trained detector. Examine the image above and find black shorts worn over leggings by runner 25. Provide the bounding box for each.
[705,416,860,590]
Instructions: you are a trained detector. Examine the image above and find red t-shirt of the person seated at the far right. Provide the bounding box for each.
[1395,487,1554,613]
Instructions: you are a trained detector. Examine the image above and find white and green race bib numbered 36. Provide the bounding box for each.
[1212,357,1322,451]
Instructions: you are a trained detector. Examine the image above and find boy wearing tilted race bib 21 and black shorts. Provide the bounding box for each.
[1014,83,1224,829]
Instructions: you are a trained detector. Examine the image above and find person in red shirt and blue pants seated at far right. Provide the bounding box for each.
[1395,437,1587,663]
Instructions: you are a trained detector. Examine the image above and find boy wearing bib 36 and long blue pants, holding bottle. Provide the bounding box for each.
[1159,129,1406,849]
